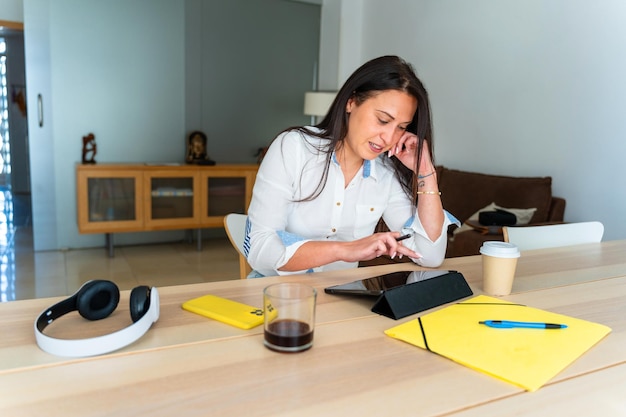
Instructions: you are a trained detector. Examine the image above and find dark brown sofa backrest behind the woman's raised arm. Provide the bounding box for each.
[437,166,552,223]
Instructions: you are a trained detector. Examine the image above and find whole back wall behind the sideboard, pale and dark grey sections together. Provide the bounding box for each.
[17,0,320,250]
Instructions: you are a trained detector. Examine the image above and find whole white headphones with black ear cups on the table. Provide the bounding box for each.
[35,280,159,357]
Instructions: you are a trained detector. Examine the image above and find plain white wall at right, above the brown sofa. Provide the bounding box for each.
[325,0,626,240]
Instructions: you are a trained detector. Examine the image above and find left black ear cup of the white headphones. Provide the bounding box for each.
[76,280,120,320]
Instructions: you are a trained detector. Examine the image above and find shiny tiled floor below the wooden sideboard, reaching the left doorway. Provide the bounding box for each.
[0,190,239,301]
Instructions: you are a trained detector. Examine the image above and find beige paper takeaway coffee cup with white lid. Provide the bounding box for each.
[480,241,520,296]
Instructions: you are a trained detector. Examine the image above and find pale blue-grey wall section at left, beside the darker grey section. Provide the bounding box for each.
[25,0,185,250]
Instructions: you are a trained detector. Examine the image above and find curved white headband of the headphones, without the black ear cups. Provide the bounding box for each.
[34,281,160,357]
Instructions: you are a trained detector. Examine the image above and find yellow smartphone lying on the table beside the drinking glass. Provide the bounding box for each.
[183,294,263,330]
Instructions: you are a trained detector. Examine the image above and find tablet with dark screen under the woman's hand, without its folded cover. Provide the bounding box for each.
[324,269,456,296]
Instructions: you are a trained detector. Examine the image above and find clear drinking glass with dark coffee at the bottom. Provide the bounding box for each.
[263,282,317,352]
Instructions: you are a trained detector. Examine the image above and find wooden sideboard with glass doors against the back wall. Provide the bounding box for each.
[76,164,258,254]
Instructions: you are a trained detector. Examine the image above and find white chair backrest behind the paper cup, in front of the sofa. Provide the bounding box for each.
[502,221,604,250]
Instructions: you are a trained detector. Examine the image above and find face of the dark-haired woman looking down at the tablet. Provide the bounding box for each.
[344,90,417,160]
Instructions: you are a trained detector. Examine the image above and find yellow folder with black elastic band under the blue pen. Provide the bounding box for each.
[385,295,611,391]
